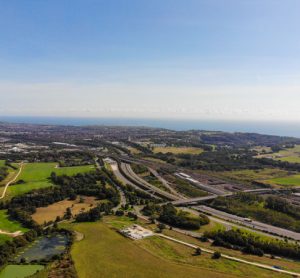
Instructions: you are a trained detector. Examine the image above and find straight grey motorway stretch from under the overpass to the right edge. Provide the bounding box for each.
[192,206,300,240]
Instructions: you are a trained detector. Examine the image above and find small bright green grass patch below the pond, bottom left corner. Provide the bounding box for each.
[0,265,44,278]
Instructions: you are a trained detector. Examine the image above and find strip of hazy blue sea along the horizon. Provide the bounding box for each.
[0,116,300,138]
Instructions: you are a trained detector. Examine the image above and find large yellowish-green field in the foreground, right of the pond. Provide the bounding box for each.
[65,220,285,278]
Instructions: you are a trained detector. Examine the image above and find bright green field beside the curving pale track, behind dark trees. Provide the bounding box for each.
[0,163,95,200]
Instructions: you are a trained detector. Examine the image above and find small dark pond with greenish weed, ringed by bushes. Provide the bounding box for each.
[14,234,69,262]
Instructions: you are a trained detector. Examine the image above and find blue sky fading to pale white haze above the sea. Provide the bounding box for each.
[0,0,300,121]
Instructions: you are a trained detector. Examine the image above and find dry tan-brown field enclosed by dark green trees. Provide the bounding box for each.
[32,197,97,224]
